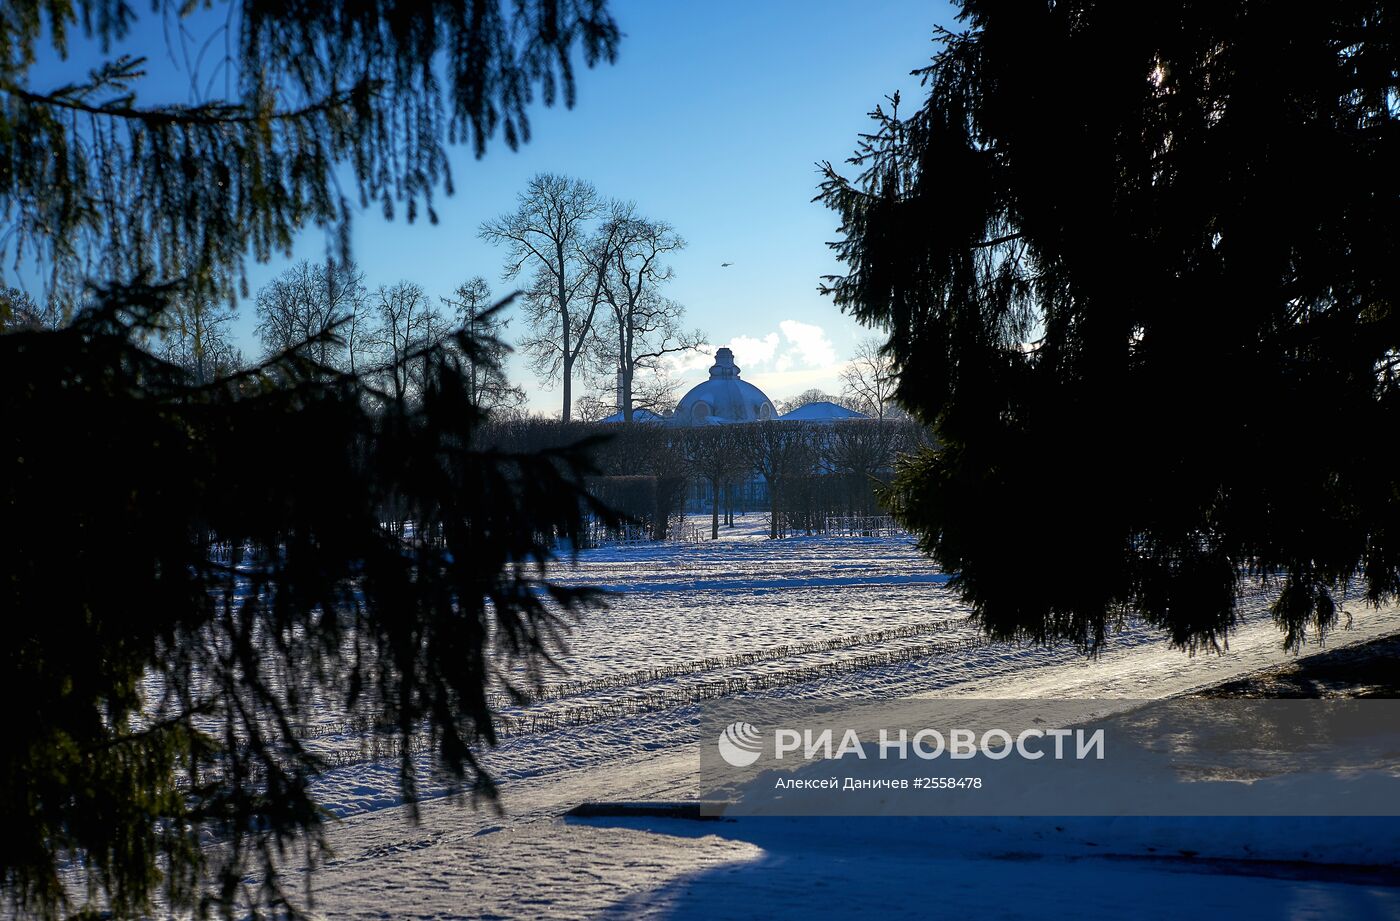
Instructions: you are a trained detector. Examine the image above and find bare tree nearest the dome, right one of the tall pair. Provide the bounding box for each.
[591,203,704,423]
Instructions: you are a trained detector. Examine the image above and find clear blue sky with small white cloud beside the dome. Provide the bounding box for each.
[27,0,956,413]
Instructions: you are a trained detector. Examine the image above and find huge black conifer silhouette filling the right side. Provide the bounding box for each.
[820,0,1400,649]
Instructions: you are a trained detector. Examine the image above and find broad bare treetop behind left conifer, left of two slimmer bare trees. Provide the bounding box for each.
[255,259,371,374]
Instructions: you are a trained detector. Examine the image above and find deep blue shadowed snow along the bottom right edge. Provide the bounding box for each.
[588,823,1400,921]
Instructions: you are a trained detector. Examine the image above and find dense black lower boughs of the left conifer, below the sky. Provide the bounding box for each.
[0,287,615,915]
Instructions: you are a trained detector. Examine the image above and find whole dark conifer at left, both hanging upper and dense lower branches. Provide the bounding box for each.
[0,0,619,917]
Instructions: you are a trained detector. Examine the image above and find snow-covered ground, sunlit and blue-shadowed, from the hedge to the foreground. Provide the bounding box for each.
[295,516,1400,918]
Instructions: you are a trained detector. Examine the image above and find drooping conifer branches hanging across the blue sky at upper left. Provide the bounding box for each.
[0,0,619,307]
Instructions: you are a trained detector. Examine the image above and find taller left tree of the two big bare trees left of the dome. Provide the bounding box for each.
[480,172,602,423]
